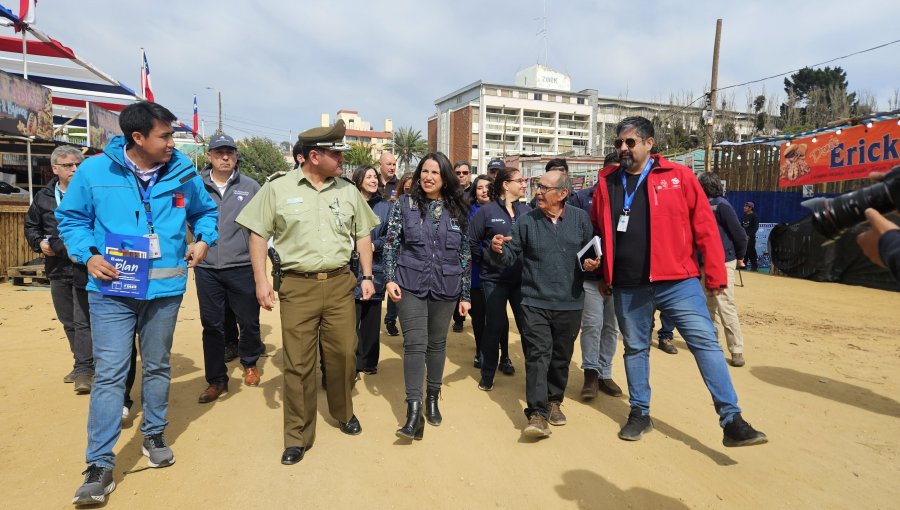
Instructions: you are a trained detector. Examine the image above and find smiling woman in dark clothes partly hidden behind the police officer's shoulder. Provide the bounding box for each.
[351,165,391,375]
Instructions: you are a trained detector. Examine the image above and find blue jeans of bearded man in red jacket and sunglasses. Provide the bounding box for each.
[613,278,741,427]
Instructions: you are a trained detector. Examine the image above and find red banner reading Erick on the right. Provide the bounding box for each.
[778,119,900,188]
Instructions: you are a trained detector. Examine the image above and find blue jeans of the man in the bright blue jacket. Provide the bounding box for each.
[86,292,182,468]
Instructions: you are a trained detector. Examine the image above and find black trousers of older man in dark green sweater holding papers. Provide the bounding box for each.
[522,305,581,418]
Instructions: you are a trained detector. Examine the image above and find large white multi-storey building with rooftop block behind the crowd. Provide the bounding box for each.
[428,64,754,170]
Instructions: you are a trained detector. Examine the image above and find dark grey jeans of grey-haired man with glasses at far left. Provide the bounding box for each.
[50,280,94,375]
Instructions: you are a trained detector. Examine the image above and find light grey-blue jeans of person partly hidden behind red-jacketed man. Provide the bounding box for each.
[581,280,619,379]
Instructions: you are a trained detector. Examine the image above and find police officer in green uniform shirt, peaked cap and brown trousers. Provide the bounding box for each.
[235,120,379,464]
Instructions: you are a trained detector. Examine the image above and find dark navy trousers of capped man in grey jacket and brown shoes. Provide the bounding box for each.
[194,266,265,385]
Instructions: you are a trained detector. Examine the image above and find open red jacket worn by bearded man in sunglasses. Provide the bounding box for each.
[591,155,728,289]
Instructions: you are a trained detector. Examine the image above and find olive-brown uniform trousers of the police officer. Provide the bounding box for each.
[278,271,356,448]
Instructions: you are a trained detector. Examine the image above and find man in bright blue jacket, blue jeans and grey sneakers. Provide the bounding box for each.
[56,101,218,505]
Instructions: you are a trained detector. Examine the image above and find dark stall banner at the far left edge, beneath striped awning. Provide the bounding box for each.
[0,71,53,140]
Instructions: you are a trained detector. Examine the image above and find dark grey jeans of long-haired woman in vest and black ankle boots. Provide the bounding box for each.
[397,292,456,402]
